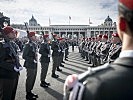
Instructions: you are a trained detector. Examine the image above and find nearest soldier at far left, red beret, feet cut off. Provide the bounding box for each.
[0,26,22,100]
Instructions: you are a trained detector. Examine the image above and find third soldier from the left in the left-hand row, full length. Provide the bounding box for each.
[39,34,51,88]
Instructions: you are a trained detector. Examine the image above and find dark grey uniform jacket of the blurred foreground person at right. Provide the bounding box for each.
[82,57,133,100]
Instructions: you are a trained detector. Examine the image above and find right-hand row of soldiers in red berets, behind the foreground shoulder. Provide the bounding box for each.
[79,33,121,67]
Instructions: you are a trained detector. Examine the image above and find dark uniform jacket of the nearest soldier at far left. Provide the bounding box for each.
[0,42,19,79]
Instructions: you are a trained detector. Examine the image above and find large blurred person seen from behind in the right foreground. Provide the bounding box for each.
[64,0,133,100]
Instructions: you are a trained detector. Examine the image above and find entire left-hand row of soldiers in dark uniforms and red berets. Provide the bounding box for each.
[0,26,69,100]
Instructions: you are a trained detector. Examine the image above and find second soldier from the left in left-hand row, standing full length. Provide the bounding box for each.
[23,32,38,99]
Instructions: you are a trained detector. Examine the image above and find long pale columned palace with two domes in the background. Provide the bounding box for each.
[12,16,117,39]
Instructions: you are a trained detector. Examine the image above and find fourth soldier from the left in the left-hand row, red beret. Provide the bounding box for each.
[51,34,61,78]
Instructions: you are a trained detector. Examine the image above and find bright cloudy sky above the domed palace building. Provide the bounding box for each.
[0,0,118,26]
